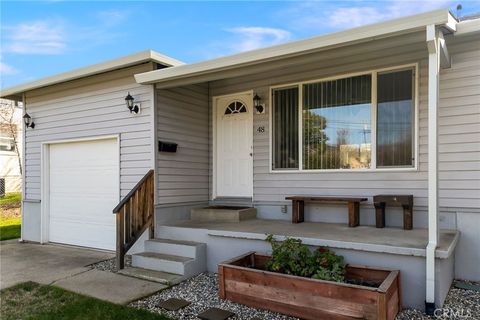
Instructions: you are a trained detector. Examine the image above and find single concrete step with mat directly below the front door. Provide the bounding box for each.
[190,206,257,222]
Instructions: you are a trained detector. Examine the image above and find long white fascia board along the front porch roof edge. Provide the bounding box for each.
[135,9,454,87]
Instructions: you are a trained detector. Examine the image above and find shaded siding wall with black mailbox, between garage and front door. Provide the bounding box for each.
[156,85,209,205]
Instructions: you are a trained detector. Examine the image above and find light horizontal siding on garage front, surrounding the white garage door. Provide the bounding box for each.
[25,63,153,199]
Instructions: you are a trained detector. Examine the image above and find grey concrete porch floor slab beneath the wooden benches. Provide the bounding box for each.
[165,219,459,259]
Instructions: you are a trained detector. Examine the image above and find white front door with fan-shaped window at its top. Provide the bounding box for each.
[215,93,253,197]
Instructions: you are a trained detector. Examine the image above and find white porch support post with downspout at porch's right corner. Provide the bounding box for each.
[425,25,443,315]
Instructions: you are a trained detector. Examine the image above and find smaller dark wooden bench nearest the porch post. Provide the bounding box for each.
[373,194,413,230]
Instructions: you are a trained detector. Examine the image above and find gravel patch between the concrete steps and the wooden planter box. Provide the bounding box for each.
[130,273,297,320]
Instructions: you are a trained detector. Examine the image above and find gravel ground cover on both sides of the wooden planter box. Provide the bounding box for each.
[130,273,480,320]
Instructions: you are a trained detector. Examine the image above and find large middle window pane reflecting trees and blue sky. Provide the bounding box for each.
[303,75,371,170]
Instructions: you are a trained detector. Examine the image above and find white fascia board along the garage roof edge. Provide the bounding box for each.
[0,50,184,100]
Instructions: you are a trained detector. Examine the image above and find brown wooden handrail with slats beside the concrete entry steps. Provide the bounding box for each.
[113,170,155,269]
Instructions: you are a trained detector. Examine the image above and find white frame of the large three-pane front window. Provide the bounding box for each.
[268,62,419,173]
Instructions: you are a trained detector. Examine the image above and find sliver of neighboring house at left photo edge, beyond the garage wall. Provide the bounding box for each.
[0,99,23,194]
